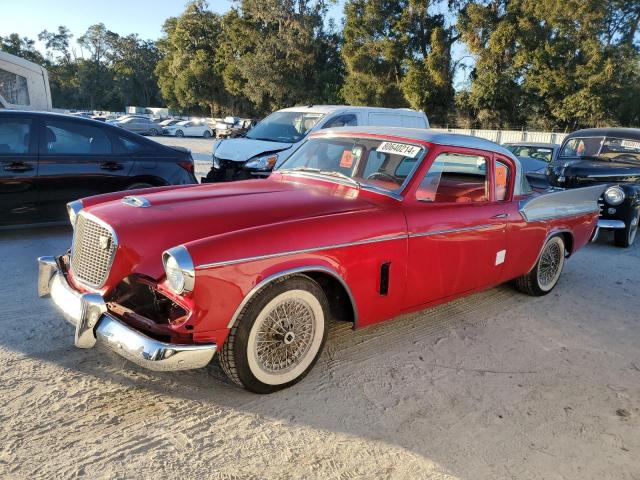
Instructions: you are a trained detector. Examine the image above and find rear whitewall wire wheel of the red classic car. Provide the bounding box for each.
[515,236,565,297]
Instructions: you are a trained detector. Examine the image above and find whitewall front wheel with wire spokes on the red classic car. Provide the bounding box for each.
[218,275,329,393]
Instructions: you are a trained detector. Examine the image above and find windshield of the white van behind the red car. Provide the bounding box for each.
[246,112,324,143]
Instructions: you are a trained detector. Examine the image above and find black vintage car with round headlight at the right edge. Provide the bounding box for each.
[548,128,640,247]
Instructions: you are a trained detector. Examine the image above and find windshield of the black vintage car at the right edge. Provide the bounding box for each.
[560,137,640,163]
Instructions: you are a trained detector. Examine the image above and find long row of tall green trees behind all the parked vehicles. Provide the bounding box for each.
[0,0,640,129]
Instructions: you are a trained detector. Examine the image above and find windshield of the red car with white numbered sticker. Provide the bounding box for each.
[277,138,425,192]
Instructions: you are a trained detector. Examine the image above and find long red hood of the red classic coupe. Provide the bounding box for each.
[84,180,378,286]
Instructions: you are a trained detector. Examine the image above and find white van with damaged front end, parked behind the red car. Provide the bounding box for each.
[202,105,429,182]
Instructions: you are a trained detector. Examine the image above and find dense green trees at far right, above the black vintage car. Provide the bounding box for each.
[458,0,640,129]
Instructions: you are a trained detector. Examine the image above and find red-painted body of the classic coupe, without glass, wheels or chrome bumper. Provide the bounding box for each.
[71,134,597,345]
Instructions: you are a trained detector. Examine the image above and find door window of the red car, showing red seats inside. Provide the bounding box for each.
[416,153,489,203]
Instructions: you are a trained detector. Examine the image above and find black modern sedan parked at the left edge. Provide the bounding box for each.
[0,110,196,228]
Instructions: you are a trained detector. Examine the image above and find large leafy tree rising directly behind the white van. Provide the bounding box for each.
[219,0,342,113]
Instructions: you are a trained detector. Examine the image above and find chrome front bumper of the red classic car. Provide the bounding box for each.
[38,257,217,371]
